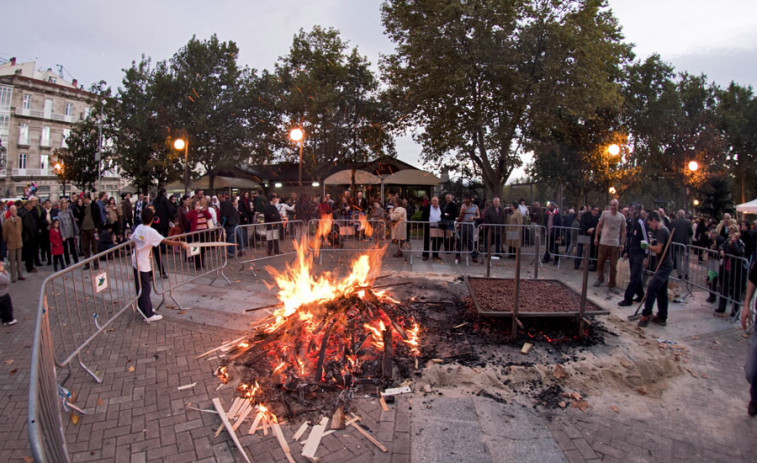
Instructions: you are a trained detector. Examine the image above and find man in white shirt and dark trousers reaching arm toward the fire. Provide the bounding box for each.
[131,207,189,322]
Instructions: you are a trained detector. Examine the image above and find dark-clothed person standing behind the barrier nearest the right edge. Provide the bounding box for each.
[715,226,746,317]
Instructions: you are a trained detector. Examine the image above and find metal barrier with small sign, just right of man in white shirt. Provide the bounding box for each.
[149,227,231,313]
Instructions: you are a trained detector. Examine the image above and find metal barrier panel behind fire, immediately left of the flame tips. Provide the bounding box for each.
[232,220,305,272]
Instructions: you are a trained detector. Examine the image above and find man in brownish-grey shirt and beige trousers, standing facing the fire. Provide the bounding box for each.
[594,199,626,293]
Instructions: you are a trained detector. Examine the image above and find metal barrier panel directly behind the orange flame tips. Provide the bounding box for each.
[308,217,389,252]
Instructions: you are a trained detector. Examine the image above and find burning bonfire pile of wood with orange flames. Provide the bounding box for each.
[216,234,420,418]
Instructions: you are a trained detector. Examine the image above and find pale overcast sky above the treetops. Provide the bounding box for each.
[0,0,757,174]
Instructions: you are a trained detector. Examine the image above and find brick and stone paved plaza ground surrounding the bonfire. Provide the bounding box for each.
[0,258,757,462]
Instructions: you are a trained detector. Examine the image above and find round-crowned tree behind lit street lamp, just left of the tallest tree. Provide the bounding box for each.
[274,26,395,167]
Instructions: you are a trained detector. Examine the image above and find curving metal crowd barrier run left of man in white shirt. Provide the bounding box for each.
[27,242,141,462]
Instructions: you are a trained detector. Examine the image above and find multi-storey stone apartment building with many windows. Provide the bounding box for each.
[0,58,122,199]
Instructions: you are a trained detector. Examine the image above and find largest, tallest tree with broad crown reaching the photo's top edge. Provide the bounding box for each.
[382,0,630,195]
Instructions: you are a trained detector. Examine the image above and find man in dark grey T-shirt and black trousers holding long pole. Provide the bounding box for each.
[639,211,673,328]
